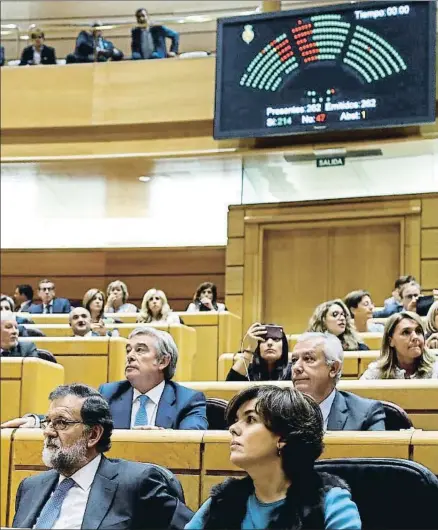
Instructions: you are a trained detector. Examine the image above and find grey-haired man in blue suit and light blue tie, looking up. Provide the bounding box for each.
[1,326,208,430]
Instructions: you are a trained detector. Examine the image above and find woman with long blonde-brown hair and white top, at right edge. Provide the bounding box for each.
[361,311,438,379]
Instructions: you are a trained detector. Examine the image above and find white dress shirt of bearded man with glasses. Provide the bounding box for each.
[45,455,102,530]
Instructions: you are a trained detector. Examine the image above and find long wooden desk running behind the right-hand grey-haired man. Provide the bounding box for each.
[184,379,438,430]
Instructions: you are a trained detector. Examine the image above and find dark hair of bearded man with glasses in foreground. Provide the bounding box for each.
[49,383,114,453]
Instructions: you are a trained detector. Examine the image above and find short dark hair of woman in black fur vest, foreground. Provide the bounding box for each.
[225,385,324,481]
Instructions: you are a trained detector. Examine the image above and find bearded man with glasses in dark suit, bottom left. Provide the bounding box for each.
[12,383,193,530]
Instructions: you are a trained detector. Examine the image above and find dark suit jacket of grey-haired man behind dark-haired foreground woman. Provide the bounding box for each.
[327,390,385,431]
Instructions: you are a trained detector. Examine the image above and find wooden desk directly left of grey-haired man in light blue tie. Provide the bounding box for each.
[20,337,109,388]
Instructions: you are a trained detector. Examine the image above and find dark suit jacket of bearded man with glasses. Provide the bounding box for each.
[12,457,193,530]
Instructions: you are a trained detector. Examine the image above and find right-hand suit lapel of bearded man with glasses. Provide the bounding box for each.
[81,456,119,530]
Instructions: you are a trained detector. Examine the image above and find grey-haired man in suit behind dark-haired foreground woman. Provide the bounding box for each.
[292,332,385,431]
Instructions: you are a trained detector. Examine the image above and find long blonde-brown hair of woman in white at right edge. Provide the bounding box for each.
[376,311,435,379]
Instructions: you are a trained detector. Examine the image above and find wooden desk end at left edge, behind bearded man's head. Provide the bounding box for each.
[0,357,64,423]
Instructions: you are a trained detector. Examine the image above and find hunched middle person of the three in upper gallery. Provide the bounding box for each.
[65,21,123,64]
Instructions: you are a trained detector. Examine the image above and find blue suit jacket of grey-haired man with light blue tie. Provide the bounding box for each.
[99,381,208,430]
